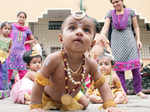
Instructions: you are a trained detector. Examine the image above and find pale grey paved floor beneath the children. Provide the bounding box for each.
[0,95,150,112]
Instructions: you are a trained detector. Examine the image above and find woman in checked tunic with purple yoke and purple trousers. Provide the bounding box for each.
[95,0,147,98]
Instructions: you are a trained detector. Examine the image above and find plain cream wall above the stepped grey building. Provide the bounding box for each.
[0,0,150,22]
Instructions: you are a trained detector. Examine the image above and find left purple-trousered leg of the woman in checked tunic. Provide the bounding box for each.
[116,71,127,93]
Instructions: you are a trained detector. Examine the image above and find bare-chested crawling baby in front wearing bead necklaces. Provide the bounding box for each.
[30,12,123,112]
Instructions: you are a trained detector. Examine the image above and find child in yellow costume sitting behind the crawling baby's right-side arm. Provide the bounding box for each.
[86,52,128,104]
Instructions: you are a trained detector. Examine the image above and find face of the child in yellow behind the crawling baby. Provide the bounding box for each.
[99,57,112,74]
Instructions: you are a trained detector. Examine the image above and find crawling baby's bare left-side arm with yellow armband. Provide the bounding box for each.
[30,55,58,109]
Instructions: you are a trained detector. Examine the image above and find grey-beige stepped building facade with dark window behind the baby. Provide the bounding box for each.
[29,9,150,59]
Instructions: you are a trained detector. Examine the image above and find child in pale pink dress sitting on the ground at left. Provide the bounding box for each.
[10,50,42,104]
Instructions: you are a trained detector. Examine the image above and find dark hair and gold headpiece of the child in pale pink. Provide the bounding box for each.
[23,50,42,66]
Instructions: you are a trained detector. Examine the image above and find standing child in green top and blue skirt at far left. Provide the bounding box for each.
[0,22,12,99]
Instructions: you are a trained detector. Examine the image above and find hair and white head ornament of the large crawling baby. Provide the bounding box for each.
[61,11,98,39]
